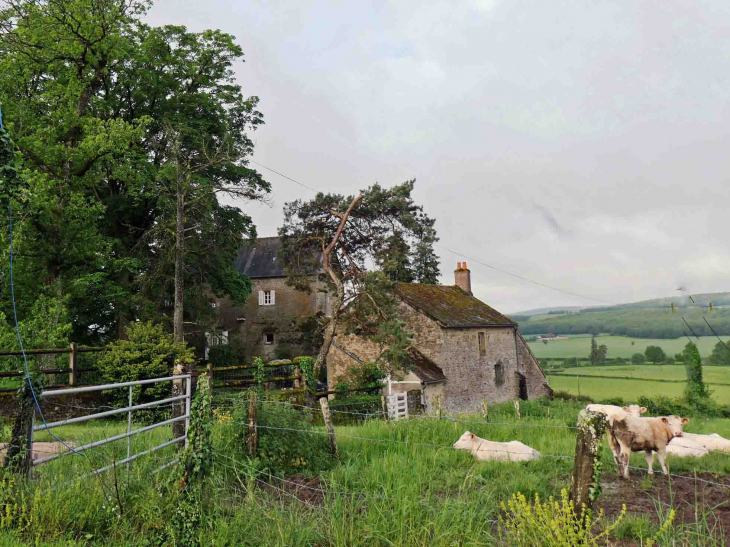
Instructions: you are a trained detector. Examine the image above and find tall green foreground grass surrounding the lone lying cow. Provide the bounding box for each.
[5,398,730,547]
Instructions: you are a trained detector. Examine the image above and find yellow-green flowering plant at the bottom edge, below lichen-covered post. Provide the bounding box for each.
[499,488,626,547]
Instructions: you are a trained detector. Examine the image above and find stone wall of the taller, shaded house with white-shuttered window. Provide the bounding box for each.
[213,277,329,361]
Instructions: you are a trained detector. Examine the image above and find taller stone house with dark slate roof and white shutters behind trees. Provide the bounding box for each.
[208,237,331,361]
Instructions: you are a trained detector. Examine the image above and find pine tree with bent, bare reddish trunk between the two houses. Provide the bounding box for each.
[279,180,439,382]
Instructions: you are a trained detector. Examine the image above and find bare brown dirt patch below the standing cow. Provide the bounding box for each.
[595,473,730,530]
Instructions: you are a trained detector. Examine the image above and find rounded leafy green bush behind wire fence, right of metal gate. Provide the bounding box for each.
[230,392,333,475]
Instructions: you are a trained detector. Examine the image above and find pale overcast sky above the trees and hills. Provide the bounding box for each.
[147,0,730,313]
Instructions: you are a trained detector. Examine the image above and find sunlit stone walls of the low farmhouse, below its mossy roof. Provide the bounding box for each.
[327,302,549,414]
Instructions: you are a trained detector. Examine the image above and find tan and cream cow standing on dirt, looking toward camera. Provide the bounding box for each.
[609,416,689,479]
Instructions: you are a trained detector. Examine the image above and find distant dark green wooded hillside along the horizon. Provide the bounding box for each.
[520,308,730,338]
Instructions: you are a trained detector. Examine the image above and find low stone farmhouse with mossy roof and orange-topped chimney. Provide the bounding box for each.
[327,263,552,413]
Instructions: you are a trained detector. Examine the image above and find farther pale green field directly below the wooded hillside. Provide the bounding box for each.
[529,335,727,359]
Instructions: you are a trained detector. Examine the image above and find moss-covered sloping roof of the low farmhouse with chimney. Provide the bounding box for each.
[395,283,517,328]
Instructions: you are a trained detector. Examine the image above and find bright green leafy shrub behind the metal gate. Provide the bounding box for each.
[97,322,193,406]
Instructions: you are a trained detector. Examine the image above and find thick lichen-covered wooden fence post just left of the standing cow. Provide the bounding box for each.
[570,410,606,518]
